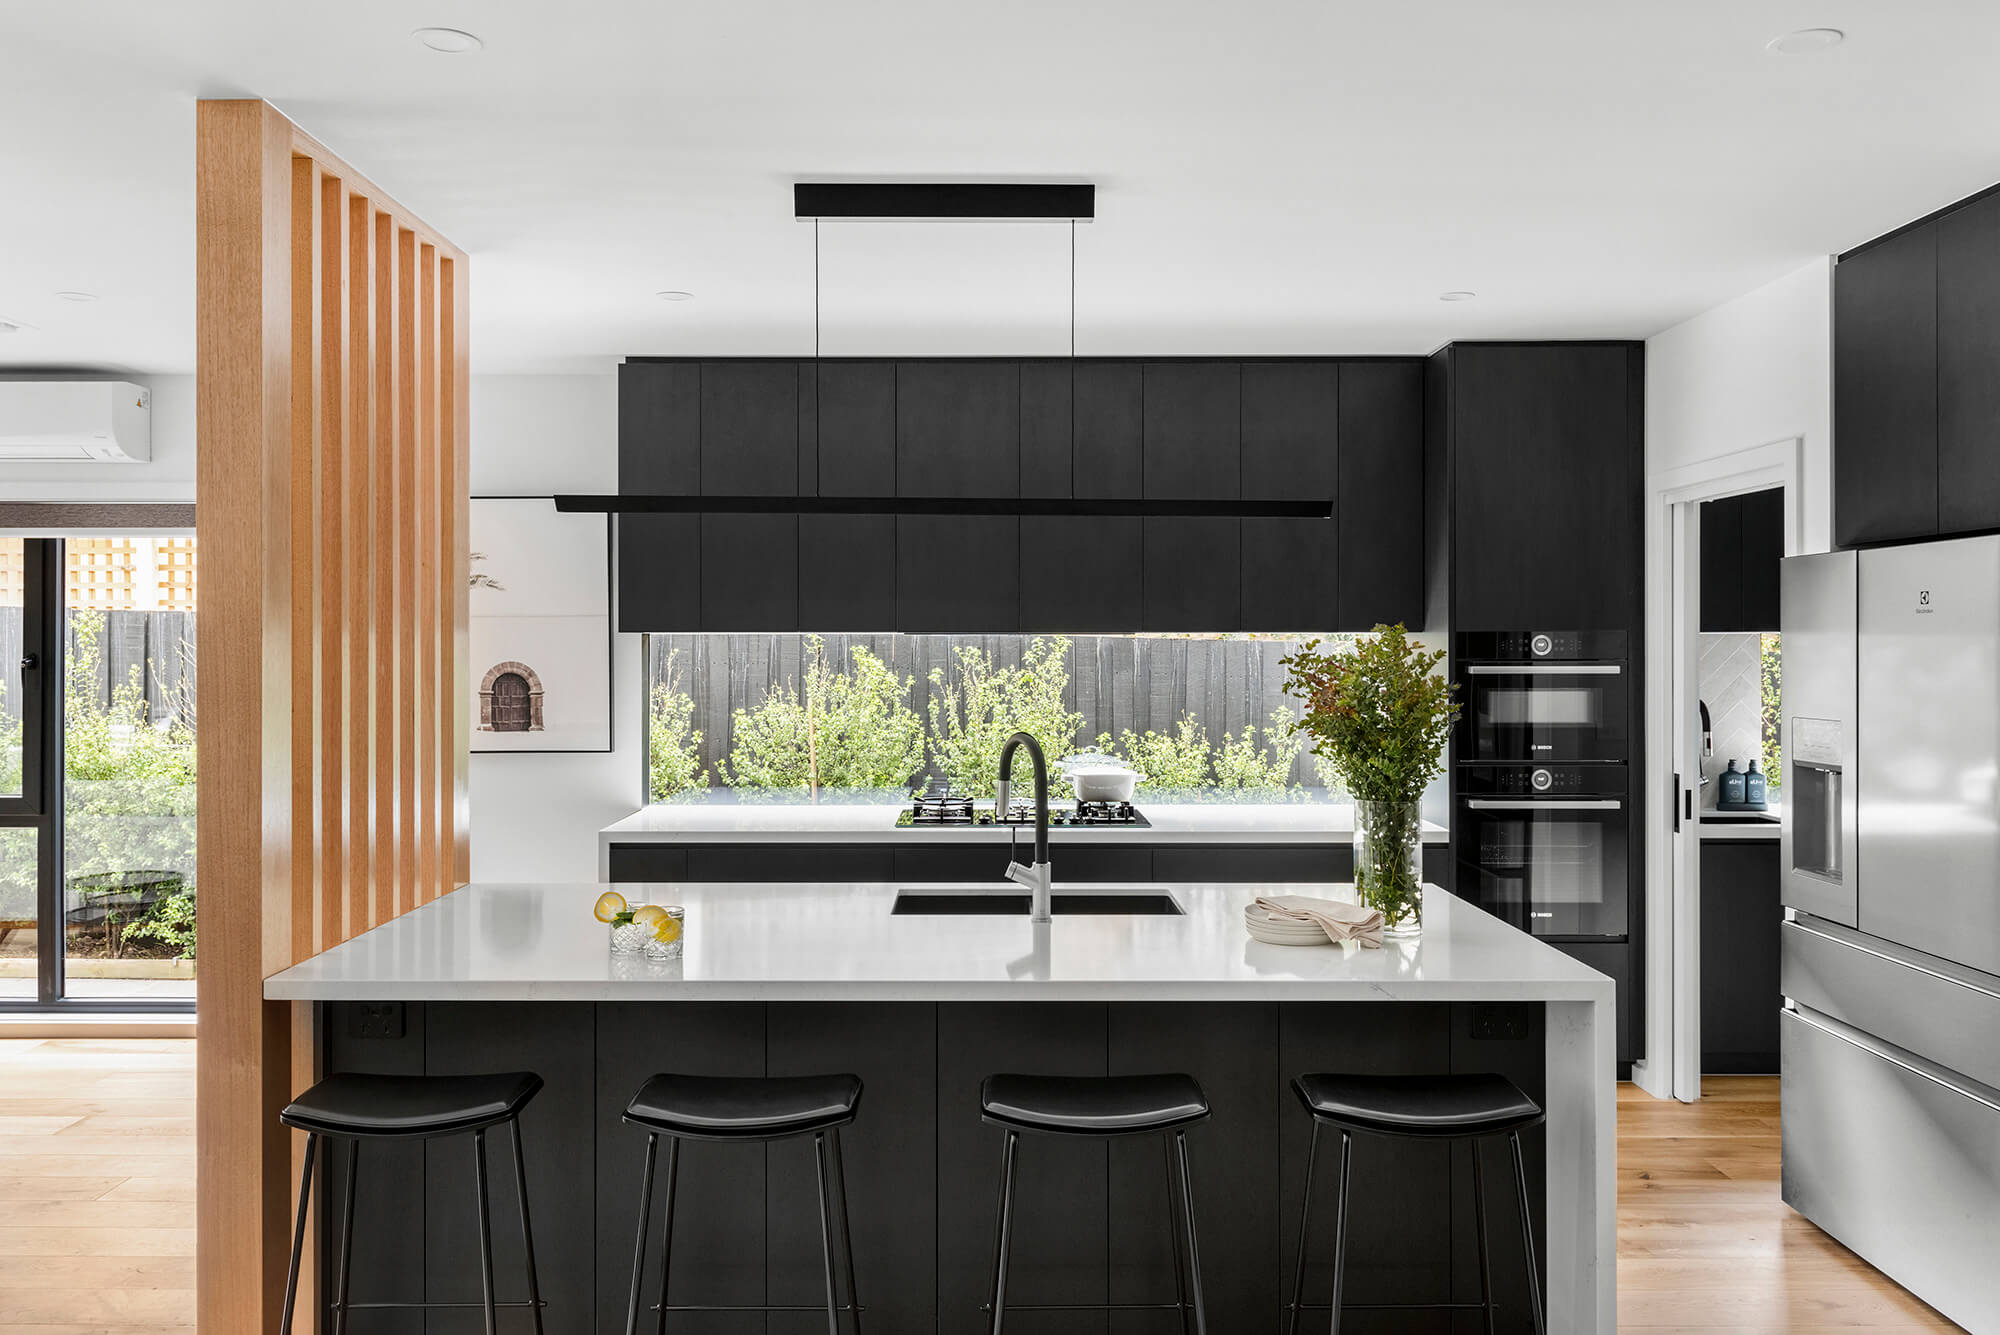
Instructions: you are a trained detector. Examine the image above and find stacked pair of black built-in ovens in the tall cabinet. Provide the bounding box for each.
[1452,632,1632,941]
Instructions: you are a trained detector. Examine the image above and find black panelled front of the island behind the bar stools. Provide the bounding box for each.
[318,1001,1546,1335]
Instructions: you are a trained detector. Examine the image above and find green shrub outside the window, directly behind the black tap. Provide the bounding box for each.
[926,636,1084,797]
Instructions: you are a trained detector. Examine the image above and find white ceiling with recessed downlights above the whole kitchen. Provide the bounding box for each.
[0,0,2000,372]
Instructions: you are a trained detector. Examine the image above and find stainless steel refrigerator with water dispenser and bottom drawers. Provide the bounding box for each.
[1780,538,2000,1331]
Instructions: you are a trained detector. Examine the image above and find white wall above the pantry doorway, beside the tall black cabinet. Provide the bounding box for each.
[1646,258,1834,551]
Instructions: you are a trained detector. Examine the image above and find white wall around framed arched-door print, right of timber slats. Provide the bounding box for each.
[472,376,644,881]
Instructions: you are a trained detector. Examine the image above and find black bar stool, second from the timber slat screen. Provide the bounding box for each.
[624,1075,862,1335]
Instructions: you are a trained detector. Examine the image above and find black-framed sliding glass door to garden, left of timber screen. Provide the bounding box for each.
[0,534,196,1009]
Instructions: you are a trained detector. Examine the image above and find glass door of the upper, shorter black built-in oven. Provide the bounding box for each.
[1464,664,1628,763]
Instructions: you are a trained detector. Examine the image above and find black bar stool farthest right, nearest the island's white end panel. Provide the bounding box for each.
[1286,1073,1546,1335]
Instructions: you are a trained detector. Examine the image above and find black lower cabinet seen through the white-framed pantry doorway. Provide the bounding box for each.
[1702,839,1784,1075]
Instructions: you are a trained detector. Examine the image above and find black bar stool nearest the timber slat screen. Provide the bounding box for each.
[278,1071,542,1335]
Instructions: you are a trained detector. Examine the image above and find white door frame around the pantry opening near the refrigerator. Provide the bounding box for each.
[1632,436,1806,1103]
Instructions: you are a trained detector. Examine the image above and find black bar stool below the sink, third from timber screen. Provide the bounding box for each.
[980,1075,1208,1335]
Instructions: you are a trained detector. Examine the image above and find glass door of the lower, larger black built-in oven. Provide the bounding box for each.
[1458,797,1626,937]
